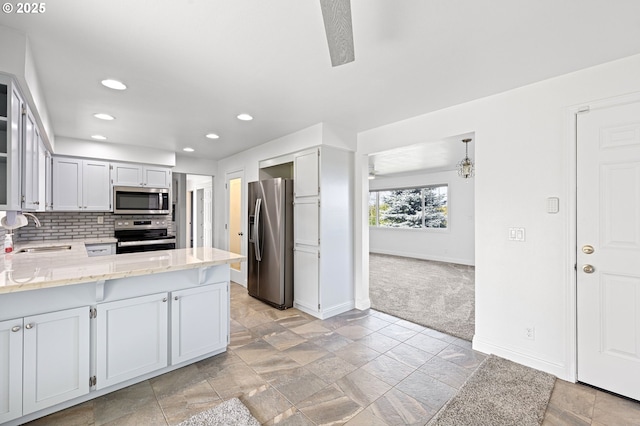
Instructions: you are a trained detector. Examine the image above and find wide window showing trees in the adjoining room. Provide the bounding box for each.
[369,185,448,229]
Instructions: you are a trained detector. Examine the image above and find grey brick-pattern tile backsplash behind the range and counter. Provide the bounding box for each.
[14,212,173,242]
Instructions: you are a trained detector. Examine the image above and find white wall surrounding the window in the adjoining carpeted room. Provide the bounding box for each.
[369,170,475,265]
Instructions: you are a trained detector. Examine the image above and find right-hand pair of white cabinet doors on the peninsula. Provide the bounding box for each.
[96,283,229,389]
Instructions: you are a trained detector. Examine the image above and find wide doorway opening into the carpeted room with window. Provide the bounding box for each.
[365,133,475,340]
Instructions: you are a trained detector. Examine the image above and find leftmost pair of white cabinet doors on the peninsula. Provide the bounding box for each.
[0,307,90,422]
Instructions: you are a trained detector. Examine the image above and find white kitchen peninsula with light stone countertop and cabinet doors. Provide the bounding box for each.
[0,240,244,425]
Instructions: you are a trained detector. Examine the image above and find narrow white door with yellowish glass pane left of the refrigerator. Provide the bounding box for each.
[225,170,247,287]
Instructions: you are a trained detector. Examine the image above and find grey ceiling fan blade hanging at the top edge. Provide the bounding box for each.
[320,0,355,67]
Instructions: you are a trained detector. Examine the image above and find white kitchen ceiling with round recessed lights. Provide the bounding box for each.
[0,0,640,163]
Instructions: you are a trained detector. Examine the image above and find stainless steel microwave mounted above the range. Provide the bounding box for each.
[113,186,171,214]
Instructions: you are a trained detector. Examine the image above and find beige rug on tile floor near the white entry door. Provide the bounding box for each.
[428,355,556,426]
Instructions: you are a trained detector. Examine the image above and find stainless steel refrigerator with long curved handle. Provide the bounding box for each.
[247,178,293,309]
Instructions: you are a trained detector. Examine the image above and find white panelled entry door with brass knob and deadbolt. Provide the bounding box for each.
[577,98,640,400]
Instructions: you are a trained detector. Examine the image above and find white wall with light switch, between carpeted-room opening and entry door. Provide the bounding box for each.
[356,51,640,380]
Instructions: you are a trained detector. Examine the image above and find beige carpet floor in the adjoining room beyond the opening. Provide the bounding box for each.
[369,253,475,341]
